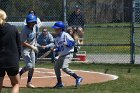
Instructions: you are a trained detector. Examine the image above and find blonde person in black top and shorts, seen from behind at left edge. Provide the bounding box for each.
[0,9,21,93]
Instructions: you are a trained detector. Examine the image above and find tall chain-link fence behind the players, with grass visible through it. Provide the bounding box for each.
[0,0,140,63]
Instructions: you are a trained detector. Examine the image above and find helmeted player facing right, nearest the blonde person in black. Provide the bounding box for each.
[19,14,38,88]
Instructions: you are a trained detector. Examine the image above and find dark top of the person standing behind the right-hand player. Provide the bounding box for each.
[68,12,85,27]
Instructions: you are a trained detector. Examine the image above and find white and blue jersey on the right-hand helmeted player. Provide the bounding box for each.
[55,31,75,56]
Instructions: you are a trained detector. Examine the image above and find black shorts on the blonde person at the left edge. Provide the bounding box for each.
[0,67,19,77]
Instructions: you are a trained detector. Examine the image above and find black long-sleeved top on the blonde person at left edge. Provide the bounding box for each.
[0,23,21,68]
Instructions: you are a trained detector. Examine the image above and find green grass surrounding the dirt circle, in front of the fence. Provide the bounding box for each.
[2,63,140,93]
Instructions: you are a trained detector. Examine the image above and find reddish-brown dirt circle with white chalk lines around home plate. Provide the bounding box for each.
[4,68,118,87]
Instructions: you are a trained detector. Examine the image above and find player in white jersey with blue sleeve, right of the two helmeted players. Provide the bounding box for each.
[52,22,83,88]
